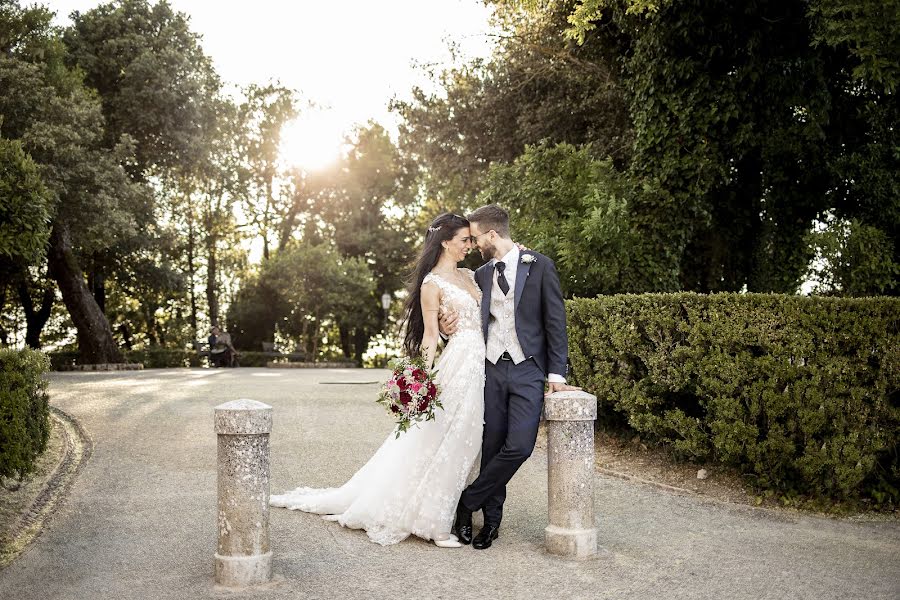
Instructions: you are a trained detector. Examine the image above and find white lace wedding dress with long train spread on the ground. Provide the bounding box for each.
[269,269,484,545]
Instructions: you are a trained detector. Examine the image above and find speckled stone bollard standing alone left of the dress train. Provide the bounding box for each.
[215,400,272,587]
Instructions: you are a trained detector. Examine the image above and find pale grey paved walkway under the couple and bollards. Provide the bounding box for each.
[0,369,900,600]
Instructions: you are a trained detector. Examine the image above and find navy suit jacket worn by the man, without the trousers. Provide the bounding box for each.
[475,250,569,377]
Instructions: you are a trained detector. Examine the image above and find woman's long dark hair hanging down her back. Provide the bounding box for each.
[400,213,469,357]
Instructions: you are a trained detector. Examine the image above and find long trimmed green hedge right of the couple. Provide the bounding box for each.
[567,293,900,506]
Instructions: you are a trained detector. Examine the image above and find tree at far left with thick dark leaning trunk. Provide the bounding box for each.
[0,2,145,362]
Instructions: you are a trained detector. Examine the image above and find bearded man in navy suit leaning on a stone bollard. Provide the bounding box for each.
[441,204,579,550]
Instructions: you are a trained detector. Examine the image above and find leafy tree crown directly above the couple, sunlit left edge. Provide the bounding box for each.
[393,2,631,214]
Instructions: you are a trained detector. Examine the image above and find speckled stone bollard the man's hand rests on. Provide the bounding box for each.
[544,391,597,558]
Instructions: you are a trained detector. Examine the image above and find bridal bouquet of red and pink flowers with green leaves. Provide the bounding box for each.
[377,358,443,437]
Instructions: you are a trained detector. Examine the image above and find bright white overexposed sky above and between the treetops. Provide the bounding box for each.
[49,0,500,167]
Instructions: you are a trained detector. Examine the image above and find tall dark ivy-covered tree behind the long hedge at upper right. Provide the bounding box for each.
[502,0,900,292]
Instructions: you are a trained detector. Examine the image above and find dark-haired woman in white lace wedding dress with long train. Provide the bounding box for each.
[270,213,485,548]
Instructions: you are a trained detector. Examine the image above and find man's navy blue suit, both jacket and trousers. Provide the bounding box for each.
[460,250,568,525]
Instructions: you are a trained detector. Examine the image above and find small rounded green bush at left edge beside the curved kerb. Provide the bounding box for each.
[0,348,50,478]
